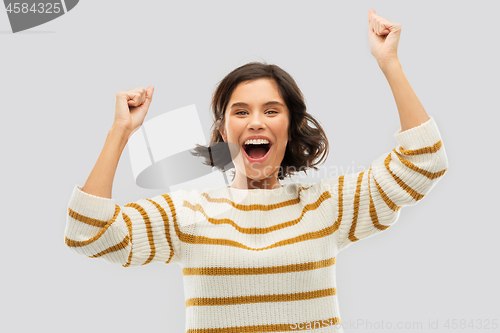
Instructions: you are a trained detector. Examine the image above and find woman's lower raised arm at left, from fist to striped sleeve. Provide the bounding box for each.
[64,86,184,267]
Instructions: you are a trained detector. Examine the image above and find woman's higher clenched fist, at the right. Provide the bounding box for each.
[368,8,401,64]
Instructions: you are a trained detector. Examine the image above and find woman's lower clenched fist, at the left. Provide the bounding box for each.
[113,86,154,137]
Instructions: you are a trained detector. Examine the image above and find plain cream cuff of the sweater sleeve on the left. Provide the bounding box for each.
[68,185,116,221]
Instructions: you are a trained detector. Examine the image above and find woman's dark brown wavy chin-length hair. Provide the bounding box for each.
[191,62,329,180]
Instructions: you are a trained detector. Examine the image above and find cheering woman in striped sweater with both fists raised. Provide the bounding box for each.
[65,9,448,333]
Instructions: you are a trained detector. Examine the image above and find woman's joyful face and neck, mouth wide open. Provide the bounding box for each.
[221,79,290,188]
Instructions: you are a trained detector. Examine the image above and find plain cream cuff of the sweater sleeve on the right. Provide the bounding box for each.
[394,117,441,149]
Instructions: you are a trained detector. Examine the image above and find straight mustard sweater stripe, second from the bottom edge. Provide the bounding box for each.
[186,288,337,308]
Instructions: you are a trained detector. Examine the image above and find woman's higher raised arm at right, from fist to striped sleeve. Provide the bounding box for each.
[322,9,448,250]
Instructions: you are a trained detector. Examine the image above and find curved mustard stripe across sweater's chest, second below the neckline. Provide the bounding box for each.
[183,191,331,235]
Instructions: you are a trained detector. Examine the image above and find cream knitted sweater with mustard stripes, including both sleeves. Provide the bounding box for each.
[65,117,448,333]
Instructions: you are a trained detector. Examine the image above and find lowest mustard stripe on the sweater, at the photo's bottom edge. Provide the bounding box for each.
[186,317,341,333]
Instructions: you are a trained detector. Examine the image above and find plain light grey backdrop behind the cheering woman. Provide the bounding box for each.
[0,0,500,333]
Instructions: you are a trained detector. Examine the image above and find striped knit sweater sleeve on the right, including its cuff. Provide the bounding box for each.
[324,117,448,251]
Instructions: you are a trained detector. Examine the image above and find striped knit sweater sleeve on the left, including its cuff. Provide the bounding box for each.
[64,185,185,267]
